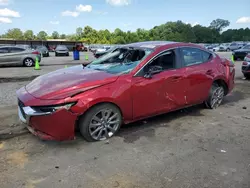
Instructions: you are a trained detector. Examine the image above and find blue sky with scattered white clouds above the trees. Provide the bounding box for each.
[0,0,250,34]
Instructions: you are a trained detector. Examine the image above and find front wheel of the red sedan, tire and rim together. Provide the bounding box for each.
[79,103,122,142]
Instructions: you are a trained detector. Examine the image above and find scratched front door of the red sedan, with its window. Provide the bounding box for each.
[132,50,185,119]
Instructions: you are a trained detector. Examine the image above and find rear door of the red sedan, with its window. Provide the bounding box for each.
[180,47,215,105]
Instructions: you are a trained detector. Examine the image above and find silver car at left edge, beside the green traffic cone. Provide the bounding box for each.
[0,46,41,67]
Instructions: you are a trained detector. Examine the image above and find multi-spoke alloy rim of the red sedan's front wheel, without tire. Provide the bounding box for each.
[89,109,121,140]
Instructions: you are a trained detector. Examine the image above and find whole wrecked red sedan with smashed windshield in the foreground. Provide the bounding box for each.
[17,41,235,141]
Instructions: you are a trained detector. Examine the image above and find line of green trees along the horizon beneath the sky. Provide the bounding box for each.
[0,19,250,44]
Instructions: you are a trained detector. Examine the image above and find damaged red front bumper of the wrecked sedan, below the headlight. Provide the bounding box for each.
[18,88,77,141]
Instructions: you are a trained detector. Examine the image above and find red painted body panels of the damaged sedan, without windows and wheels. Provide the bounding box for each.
[17,43,235,141]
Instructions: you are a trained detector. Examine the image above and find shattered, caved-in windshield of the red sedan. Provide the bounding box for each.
[87,48,153,75]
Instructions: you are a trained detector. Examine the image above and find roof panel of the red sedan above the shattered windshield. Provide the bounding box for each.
[124,41,178,49]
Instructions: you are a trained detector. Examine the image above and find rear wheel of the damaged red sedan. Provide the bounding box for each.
[205,83,225,109]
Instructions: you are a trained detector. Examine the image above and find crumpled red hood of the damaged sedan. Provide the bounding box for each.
[25,65,118,99]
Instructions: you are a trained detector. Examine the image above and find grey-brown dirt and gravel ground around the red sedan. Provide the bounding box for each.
[0,53,250,188]
